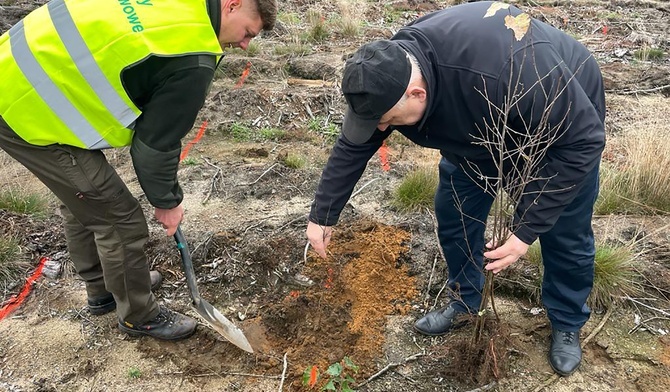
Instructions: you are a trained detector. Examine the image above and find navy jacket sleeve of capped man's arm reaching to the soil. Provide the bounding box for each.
[309,132,390,226]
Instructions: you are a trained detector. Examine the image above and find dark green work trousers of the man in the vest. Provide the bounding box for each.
[0,117,158,324]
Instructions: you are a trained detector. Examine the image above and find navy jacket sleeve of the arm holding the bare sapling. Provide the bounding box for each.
[510,45,605,244]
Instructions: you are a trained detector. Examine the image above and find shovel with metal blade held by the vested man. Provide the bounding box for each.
[174,227,254,353]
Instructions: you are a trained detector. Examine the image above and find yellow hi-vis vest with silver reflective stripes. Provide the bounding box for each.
[0,0,222,149]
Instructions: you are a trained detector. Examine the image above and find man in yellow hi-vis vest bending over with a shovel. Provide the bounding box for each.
[0,0,277,340]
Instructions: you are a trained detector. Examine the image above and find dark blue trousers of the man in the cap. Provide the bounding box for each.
[435,158,599,331]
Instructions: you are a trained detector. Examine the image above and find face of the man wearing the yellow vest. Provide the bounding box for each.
[219,0,263,50]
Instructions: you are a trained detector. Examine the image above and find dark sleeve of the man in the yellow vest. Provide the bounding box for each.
[123,55,216,209]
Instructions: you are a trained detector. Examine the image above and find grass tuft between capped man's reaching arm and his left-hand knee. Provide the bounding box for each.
[391,168,439,212]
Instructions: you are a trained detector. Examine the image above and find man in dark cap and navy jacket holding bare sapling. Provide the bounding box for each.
[307,2,605,376]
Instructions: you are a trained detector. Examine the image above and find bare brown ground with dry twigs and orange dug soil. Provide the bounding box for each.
[0,0,670,391]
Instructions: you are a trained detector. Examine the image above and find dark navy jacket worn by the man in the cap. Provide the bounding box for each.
[310,2,605,244]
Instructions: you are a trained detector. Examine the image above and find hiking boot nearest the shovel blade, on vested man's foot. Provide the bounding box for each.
[119,306,198,340]
